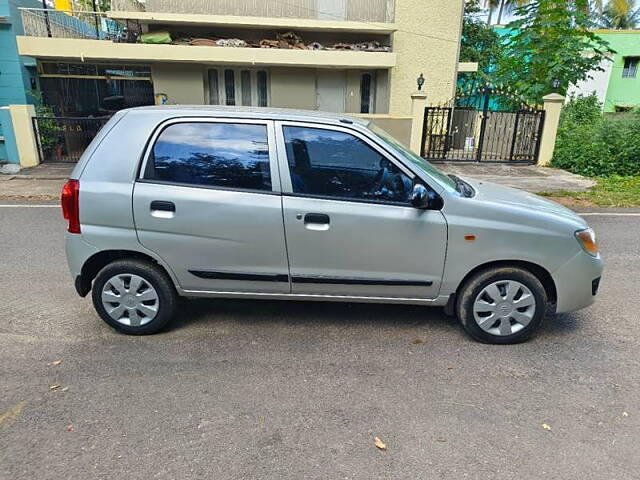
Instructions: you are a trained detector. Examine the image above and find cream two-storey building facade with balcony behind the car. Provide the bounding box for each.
[17,0,464,117]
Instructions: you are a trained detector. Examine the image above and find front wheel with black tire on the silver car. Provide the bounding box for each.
[456,267,549,345]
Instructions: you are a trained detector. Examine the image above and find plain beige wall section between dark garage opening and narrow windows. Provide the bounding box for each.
[151,63,205,105]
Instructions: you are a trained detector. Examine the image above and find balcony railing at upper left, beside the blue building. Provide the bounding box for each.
[20,8,137,42]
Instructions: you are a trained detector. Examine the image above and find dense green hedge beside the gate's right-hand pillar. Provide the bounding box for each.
[551,96,640,177]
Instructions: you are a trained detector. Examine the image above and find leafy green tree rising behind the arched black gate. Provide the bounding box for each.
[497,0,615,103]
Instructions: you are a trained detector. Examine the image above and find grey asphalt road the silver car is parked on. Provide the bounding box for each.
[0,204,640,480]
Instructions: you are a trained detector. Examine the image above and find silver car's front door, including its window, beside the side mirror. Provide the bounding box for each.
[276,122,447,299]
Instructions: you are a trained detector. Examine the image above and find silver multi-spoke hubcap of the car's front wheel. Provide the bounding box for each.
[473,280,536,336]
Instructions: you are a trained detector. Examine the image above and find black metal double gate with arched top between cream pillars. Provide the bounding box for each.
[421,87,545,163]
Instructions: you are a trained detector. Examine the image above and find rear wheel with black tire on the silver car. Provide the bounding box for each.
[91,259,178,335]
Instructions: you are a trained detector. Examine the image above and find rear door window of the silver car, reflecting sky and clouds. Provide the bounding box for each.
[144,122,271,191]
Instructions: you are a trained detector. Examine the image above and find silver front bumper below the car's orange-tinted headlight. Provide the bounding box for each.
[552,251,603,313]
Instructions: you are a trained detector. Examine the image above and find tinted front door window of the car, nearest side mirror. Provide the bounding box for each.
[284,127,413,204]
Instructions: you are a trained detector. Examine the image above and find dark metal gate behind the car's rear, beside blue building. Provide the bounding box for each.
[33,117,110,163]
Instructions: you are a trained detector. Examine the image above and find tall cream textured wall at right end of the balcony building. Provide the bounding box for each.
[389,0,464,115]
